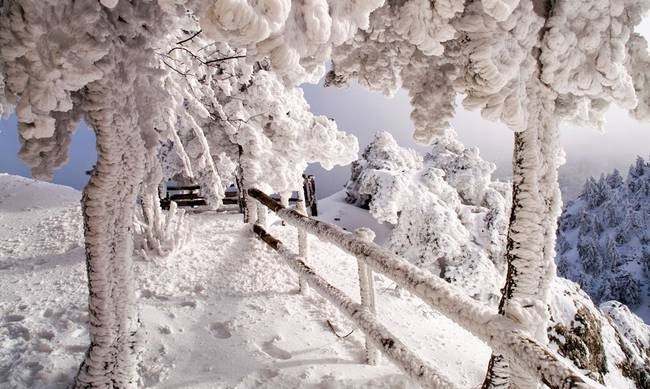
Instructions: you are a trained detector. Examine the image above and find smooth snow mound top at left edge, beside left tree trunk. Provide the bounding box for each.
[0,173,81,212]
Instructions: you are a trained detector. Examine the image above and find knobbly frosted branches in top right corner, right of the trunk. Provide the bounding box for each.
[540,0,650,126]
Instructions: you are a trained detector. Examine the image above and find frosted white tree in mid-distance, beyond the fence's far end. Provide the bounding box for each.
[158,31,358,217]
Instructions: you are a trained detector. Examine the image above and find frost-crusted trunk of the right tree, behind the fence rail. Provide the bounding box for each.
[483,80,563,388]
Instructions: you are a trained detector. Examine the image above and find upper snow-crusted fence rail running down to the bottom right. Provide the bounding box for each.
[248,189,602,389]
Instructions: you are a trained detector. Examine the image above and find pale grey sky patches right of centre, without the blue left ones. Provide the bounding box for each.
[303,17,650,196]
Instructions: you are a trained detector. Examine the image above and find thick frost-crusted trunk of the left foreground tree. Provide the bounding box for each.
[75,80,146,388]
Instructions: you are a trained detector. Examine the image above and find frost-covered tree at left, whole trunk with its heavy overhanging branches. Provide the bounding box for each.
[0,1,190,387]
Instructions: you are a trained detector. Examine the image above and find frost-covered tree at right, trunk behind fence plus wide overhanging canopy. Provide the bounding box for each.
[327,0,650,386]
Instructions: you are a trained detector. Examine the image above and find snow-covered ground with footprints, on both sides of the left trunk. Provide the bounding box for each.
[0,174,490,388]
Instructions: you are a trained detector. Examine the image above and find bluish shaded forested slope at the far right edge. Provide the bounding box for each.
[557,158,650,320]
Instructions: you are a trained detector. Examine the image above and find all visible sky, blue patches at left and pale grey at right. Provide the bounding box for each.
[0,17,650,197]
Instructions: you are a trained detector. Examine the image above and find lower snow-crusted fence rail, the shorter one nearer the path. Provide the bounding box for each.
[253,224,456,388]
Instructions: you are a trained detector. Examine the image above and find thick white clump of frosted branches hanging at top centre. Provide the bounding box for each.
[198,0,383,85]
